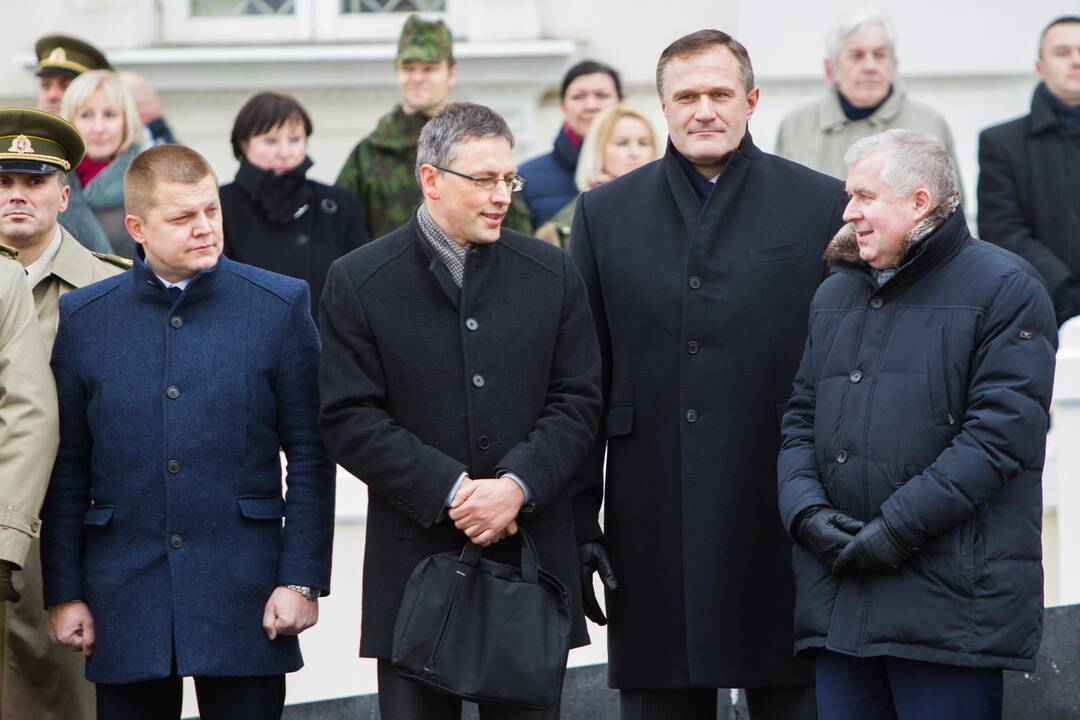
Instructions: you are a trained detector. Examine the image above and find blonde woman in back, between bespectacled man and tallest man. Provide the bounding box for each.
[537,103,658,249]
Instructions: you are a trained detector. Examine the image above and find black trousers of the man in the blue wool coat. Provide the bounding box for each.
[97,675,285,720]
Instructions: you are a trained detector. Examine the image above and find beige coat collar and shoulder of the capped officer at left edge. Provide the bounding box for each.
[31,228,132,356]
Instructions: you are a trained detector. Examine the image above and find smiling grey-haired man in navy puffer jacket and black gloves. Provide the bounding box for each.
[778,130,1057,720]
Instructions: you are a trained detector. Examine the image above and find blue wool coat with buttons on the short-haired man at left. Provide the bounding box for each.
[41,257,334,683]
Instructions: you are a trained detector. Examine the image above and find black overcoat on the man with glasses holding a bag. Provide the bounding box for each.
[320,216,600,658]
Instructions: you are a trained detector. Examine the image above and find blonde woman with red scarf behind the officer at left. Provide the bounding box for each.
[59,70,143,258]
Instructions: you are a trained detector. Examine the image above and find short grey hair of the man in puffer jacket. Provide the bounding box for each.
[843,127,960,205]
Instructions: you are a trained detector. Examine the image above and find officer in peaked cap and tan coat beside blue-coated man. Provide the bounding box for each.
[0,108,131,720]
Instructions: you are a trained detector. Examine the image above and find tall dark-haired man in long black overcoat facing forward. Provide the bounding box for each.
[571,30,846,720]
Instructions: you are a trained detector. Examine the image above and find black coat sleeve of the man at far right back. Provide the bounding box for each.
[977,131,1072,293]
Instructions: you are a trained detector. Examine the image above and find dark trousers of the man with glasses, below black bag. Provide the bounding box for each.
[378,660,559,720]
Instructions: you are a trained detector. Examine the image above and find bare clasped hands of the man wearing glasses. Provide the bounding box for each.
[449,477,525,547]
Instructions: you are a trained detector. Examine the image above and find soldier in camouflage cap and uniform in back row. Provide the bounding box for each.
[336,15,532,239]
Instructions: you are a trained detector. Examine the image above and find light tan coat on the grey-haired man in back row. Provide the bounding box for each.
[774,83,956,188]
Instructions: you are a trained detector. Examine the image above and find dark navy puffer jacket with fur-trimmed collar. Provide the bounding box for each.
[779,205,1057,670]
